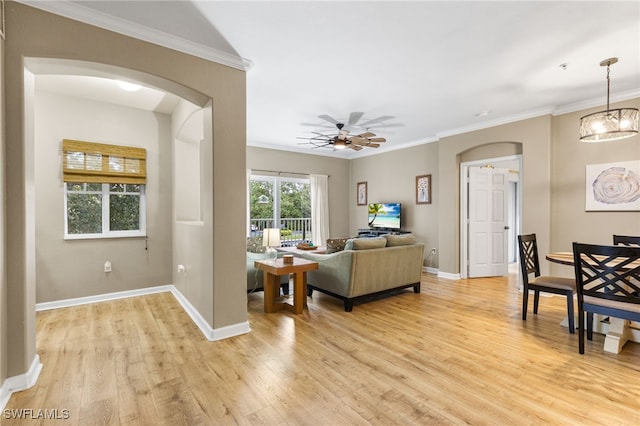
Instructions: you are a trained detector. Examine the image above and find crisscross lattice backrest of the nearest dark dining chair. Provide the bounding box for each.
[573,243,640,304]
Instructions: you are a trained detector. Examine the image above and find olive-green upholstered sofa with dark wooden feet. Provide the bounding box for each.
[300,234,424,312]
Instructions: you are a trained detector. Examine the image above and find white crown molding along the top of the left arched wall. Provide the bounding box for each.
[16,0,253,71]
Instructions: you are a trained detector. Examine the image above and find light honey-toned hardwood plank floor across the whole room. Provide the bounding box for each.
[5,275,640,426]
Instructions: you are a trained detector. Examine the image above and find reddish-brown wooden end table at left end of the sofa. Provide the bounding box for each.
[254,257,318,314]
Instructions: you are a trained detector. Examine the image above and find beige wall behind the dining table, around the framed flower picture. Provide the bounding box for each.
[550,98,640,276]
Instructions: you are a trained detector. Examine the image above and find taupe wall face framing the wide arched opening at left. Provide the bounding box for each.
[3,2,247,376]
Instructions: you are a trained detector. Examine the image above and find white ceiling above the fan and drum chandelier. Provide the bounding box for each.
[24,1,640,158]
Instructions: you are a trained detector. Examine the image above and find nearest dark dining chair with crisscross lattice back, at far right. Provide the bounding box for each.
[573,243,640,354]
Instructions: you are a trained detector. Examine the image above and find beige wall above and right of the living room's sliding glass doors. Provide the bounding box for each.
[247,147,352,237]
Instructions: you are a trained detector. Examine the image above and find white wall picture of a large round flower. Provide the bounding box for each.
[585,160,640,211]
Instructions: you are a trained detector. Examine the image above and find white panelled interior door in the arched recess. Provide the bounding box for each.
[468,167,509,277]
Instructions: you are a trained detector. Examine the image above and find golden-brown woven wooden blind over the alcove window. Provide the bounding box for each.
[62,139,147,185]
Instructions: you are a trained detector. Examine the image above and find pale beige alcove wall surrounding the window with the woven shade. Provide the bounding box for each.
[35,91,172,303]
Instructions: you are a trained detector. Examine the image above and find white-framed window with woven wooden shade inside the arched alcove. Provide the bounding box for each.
[63,140,146,239]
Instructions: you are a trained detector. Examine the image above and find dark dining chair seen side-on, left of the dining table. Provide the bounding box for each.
[518,234,576,333]
